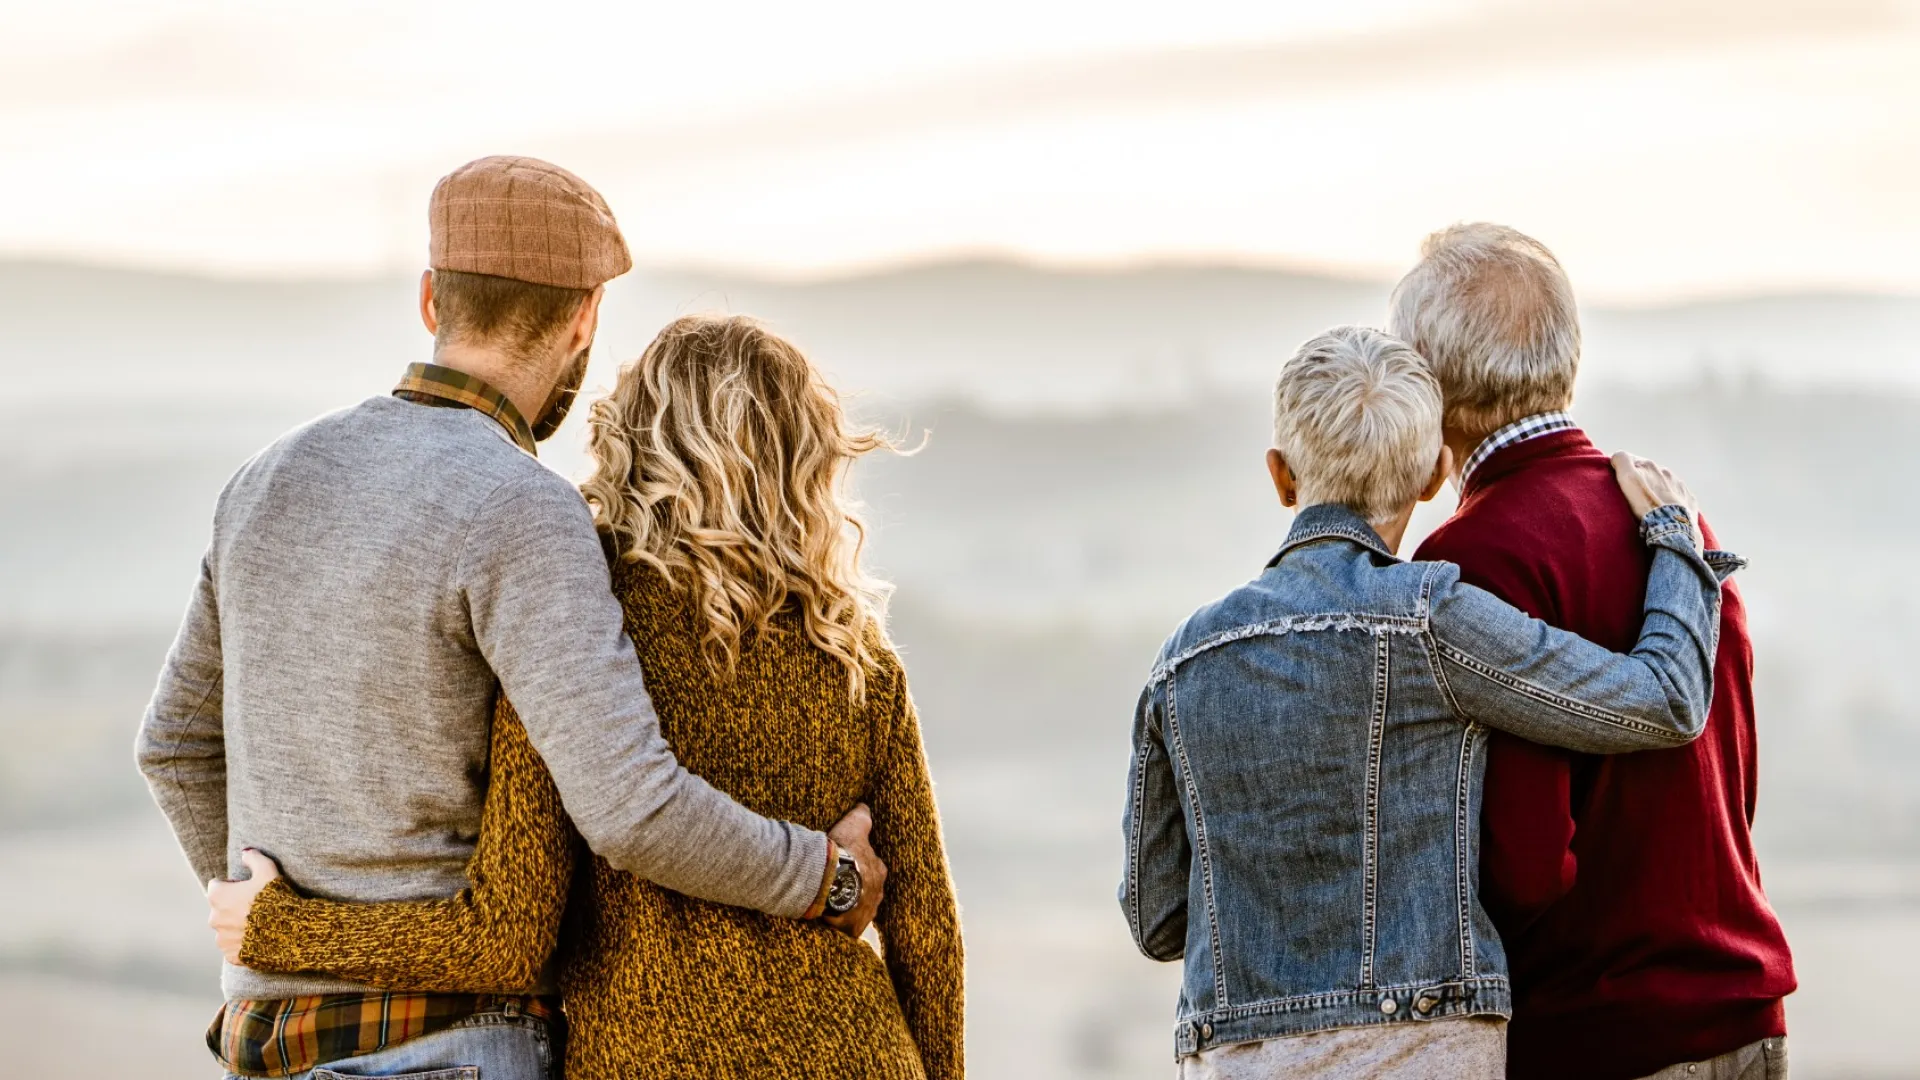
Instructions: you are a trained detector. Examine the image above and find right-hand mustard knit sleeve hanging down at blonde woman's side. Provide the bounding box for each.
[874,673,966,1080]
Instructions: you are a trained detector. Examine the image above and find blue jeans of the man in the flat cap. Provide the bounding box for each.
[228,1011,553,1080]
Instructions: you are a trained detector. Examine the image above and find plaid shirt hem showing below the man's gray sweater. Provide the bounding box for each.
[207,992,557,1076]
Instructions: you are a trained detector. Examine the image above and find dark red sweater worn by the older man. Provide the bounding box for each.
[1417,430,1795,1080]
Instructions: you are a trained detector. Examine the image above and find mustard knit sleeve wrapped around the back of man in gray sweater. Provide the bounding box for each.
[240,701,574,994]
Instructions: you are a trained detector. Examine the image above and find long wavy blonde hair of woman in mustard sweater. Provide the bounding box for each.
[580,315,893,700]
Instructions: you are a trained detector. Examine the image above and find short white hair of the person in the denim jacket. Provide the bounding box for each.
[1273,327,1440,525]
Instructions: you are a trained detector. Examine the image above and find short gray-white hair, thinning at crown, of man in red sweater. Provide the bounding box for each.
[1386,223,1580,436]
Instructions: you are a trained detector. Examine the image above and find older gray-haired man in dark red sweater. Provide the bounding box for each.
[1390,225,1795,1080]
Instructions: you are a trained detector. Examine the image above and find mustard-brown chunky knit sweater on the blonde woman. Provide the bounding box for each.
[240,565,964,1080]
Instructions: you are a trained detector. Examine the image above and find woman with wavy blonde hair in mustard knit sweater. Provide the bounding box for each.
[217,317,962,1080]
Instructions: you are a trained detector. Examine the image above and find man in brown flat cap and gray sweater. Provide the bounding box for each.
[138,158,885,1080]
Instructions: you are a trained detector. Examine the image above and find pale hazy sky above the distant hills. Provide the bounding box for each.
[0,0,1920,300]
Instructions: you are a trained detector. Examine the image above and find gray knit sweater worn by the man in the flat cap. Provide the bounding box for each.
[138,390,828,999]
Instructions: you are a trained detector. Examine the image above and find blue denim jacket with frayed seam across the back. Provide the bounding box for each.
[1119,505,1741,1057]
